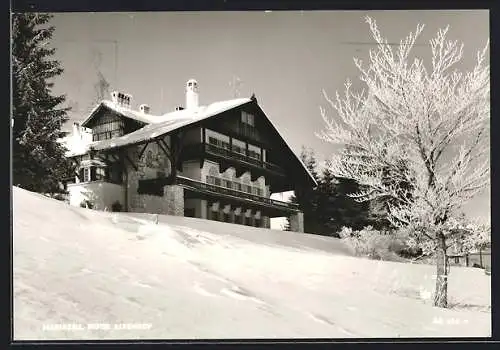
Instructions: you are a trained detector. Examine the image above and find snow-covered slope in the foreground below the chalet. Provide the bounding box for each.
[13,188,491,340]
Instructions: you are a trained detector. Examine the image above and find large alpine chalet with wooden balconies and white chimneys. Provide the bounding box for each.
[65,79,316,232]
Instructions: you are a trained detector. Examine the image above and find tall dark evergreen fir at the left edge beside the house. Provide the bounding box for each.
[12,13,70,193]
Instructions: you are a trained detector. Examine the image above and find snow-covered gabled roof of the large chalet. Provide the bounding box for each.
[69,98,317,186]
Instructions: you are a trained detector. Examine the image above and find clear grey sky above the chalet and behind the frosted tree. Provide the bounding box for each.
[51,10,490,224]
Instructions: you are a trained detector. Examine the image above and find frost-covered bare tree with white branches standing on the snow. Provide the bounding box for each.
[317,17,490,307]
